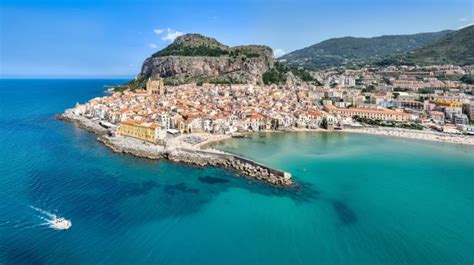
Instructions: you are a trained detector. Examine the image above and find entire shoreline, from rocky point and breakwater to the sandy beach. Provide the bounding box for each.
[55,109,474,186]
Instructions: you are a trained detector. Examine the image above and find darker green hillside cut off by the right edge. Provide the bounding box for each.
[406,26,474,65]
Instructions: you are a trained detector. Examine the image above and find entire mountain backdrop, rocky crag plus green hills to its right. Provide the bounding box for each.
[128,26,474,88]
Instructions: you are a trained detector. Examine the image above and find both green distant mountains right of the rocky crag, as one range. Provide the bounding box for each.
[279,26,474,70]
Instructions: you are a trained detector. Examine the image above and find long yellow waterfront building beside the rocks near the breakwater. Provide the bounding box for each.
[117,119,166,143]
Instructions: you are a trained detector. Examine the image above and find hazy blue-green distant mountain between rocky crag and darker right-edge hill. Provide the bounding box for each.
[279,30,451,70]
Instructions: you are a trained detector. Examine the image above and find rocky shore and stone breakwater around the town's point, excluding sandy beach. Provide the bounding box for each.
[56,110,294,187]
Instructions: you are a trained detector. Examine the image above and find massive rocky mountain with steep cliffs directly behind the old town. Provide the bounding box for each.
[134,34,274,86]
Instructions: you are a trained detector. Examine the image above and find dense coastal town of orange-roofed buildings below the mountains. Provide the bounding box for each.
[66,65,474,145]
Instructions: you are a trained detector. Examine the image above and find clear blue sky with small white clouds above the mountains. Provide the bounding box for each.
[0,0,474,77]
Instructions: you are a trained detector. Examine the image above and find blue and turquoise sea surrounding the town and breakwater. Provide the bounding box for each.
[0,80,474,265]
